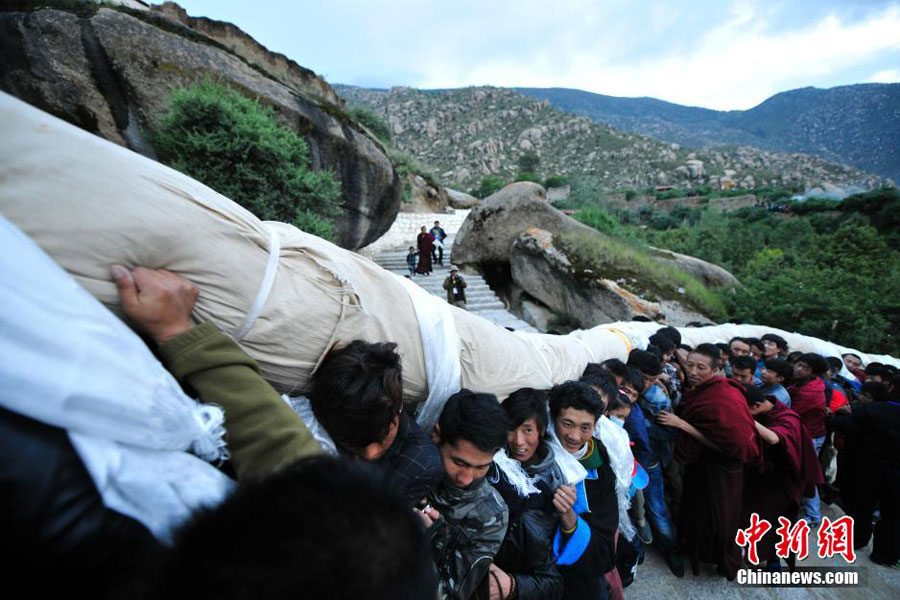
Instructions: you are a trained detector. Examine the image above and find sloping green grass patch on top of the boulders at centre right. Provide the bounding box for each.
[559,233,727,320]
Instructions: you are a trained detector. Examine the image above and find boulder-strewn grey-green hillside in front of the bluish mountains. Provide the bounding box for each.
[334,85,882,189]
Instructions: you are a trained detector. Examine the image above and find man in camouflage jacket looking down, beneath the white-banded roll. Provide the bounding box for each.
[429,389,506,600]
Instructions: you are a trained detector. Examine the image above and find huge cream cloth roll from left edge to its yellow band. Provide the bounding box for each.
[0,94,632,428]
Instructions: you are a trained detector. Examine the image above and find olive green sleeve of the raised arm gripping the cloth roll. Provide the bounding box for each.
[159,323,322,480]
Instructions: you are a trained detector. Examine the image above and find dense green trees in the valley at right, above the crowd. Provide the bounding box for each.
[576,187,900,355]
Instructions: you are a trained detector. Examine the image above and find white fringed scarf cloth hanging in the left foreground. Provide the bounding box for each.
[0,217,233,542]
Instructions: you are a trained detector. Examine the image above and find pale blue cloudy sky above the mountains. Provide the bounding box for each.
[178,0,900,110]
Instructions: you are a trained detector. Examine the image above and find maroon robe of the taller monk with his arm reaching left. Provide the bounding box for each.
[675,375,760,579]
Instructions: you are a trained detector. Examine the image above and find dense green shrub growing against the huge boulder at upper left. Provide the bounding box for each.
[149,81,340,239]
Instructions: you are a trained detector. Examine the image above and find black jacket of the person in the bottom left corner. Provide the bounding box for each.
[0,408,161,598]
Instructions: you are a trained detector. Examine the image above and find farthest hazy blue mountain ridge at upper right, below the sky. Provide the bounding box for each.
[515,83,900,182]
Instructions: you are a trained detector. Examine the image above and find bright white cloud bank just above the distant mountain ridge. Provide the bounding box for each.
[419,2,900,109]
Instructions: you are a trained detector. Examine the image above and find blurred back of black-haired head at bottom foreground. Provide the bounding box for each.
[141,457,437,600]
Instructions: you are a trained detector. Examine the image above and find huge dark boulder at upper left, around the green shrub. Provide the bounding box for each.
[0,0,402,248]
